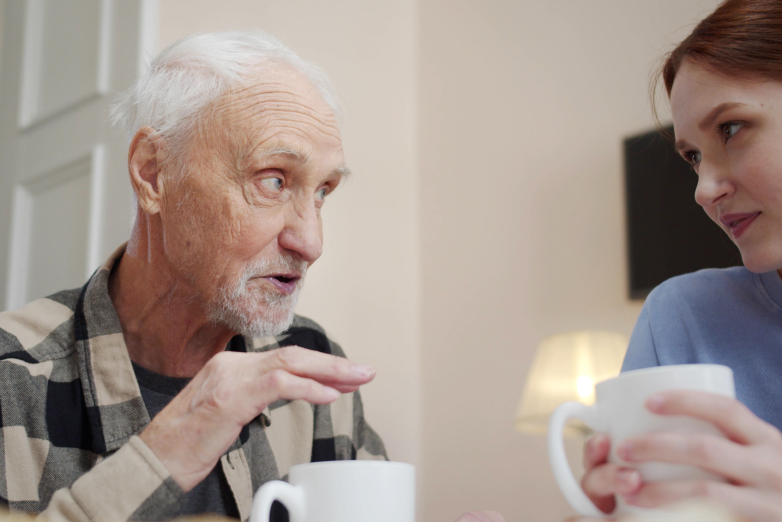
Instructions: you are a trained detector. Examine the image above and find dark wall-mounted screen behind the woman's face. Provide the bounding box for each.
[625,124,741,299]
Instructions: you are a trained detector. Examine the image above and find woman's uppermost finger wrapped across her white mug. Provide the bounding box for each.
[646,390,782,444]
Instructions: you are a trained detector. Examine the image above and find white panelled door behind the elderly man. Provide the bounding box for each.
[0,0,158,309]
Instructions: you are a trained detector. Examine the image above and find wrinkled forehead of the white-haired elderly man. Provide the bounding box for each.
[215,65,342,156]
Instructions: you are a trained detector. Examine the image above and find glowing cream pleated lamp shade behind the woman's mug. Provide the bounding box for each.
[516,331,628,436]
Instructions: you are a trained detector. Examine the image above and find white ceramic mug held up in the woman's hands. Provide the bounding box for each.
[548,364,736,517]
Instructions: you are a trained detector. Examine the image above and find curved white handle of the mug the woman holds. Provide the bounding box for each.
[548,402,609,518]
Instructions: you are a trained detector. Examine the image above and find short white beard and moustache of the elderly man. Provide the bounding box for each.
[208,256,307,337]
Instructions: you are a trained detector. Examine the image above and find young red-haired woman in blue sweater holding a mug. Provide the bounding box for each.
[582,0,782,521]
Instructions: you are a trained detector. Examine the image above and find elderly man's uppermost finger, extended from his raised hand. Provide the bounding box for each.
[257,346,375,386]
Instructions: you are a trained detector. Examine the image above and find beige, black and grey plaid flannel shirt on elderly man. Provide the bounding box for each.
[0,246,386,522]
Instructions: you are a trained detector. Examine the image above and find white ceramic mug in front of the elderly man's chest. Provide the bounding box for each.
[250,460,415,522]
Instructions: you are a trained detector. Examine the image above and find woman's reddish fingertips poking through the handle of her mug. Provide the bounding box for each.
[581,433,642,513]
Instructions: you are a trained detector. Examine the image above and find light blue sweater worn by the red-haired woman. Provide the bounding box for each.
[622,267,782,430]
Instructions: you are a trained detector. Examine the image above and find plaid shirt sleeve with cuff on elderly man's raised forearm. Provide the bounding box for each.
[38,436,185,522]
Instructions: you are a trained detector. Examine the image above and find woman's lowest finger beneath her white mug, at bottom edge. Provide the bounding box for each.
[625,480,782,522]
